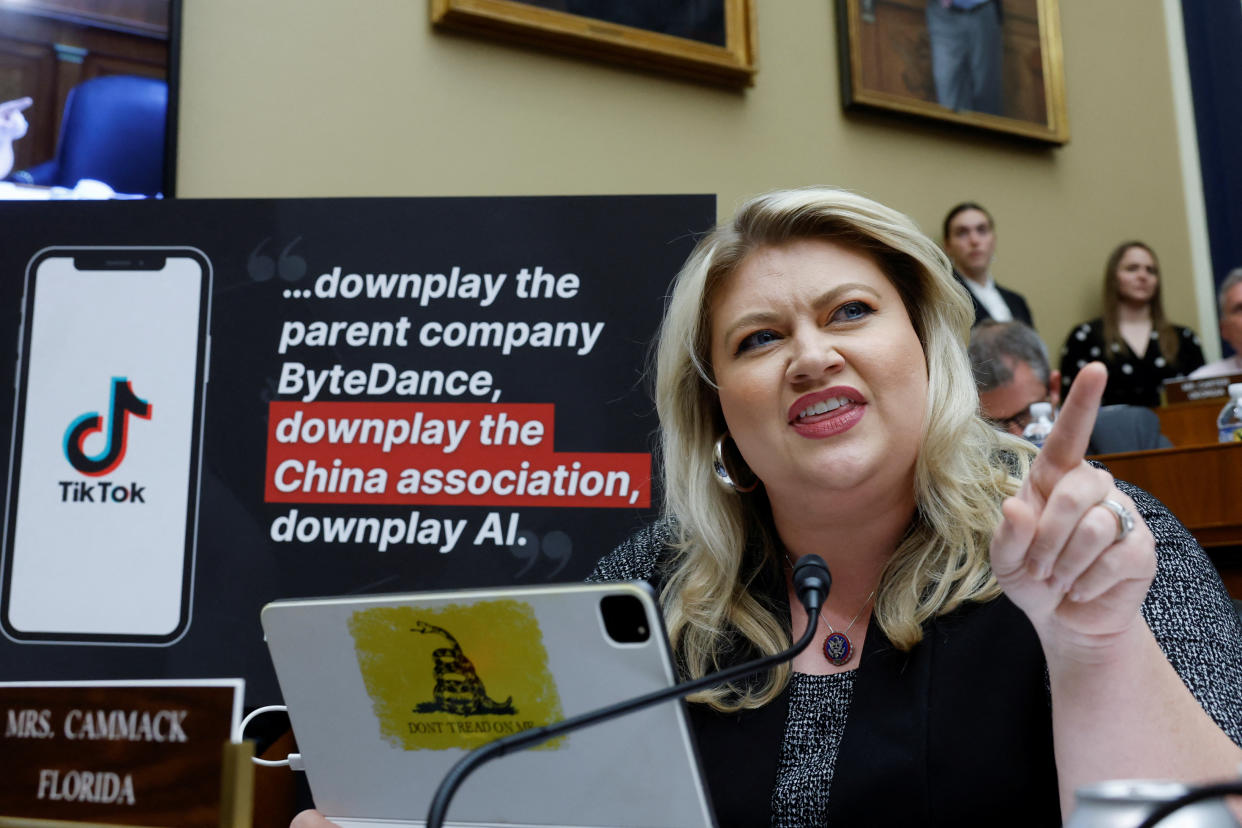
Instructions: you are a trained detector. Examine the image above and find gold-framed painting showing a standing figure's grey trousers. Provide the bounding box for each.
[837,0,1069,144]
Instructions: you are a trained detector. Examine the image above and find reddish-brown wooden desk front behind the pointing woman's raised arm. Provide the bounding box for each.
[1093,444,1242,597]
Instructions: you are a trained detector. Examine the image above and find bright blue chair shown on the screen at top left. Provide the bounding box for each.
[14,74,168,196]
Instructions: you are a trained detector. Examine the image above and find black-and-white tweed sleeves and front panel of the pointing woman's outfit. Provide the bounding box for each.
[591,480,1242,827]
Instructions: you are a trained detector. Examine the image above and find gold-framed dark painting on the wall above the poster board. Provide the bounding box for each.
[431,0,756,87]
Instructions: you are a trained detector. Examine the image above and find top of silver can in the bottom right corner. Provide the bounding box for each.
[1066,780,1238,828]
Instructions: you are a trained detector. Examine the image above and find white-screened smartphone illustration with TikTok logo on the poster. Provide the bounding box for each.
[0,247,211,646]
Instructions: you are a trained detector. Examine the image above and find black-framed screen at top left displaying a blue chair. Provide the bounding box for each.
[0,0,181,197]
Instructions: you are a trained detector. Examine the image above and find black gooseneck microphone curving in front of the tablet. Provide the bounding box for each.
[427,554,832,828]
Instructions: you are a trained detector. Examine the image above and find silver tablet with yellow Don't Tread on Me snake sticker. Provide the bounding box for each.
[262,582,715,828]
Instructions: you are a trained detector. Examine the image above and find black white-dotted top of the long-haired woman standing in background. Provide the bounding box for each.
[1061,319,1203,408]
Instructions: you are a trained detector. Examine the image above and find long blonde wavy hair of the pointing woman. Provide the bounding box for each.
[656,187,1032,711]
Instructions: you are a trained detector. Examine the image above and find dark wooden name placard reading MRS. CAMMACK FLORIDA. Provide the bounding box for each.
[0,679,243,828]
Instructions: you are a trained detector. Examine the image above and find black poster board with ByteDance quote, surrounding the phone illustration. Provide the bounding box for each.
[0,196,715,704]
